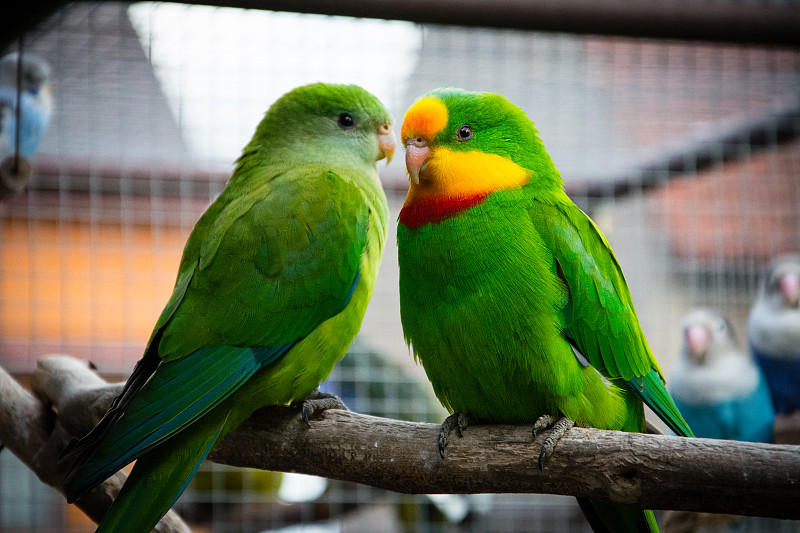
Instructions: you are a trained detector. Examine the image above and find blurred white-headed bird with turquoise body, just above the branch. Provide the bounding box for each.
[669,309,775,442]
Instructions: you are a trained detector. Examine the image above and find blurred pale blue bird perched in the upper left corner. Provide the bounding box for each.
[0,52,53,161]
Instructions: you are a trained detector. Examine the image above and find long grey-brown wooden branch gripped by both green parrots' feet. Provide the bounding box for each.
[0,358,800,519]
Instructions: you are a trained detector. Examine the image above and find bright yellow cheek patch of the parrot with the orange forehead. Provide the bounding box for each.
[405,146,530,205]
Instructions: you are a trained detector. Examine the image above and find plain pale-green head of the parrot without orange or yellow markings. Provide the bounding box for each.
[240,83,395,169]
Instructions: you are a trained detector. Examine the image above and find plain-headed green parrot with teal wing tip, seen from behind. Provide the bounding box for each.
[57,83,395,532]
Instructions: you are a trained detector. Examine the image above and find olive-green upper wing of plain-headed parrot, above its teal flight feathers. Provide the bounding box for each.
[159,171,369,360]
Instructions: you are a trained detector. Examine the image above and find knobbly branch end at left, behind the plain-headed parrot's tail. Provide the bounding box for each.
[0,356,190,533]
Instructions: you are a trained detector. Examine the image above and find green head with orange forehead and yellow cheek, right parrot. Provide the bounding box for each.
[401,88,562,203]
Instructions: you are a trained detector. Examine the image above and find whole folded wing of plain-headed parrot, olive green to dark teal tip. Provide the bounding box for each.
[62,166,369,500]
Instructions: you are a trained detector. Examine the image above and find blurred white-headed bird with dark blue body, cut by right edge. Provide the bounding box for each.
[747,254,800,415]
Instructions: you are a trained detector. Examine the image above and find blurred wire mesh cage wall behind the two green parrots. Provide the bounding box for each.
[0,2,800,531]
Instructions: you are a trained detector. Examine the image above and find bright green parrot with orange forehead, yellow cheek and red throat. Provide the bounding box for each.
[397,89,691,531]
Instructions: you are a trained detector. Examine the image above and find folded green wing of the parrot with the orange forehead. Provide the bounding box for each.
[530,195,693,436]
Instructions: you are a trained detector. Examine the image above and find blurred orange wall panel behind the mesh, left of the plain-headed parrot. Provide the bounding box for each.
[0,218,188,366]
